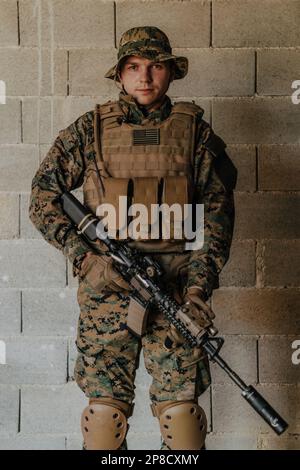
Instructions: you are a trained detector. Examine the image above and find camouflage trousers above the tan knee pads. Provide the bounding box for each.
[74,280,210,448]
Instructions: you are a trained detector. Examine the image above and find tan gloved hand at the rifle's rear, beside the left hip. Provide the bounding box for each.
[79,252,131,292]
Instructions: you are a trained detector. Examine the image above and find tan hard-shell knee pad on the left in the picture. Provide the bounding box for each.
[81,397,133,450]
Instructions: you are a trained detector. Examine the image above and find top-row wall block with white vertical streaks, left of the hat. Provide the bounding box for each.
[20,0,114,47]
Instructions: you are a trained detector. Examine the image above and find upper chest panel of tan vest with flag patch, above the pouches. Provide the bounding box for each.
[95,102,201,178]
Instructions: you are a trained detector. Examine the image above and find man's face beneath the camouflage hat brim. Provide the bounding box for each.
[120,56,173,107]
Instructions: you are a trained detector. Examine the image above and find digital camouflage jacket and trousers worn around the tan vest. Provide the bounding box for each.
[30,26,235,449]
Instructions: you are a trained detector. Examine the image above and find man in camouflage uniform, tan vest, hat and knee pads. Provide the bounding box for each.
[30,26,236,450]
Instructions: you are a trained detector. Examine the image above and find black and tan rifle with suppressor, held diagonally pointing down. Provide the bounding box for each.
[61,192,288,435]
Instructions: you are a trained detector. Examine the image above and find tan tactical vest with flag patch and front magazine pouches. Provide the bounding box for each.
[83,101,203,252]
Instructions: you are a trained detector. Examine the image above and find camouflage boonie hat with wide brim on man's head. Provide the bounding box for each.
[105,26,188,82]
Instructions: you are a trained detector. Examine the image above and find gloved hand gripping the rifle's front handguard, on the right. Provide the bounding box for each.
[165,286,217,349]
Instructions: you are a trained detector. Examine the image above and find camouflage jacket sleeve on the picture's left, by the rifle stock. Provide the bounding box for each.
[29,113,94,276]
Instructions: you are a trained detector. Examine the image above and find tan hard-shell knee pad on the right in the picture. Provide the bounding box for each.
[151,401,207,450]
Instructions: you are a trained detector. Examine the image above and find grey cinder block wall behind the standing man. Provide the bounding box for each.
[0,0,300,449]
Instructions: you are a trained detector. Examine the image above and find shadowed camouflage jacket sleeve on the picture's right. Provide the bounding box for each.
[187,120,236,300]
